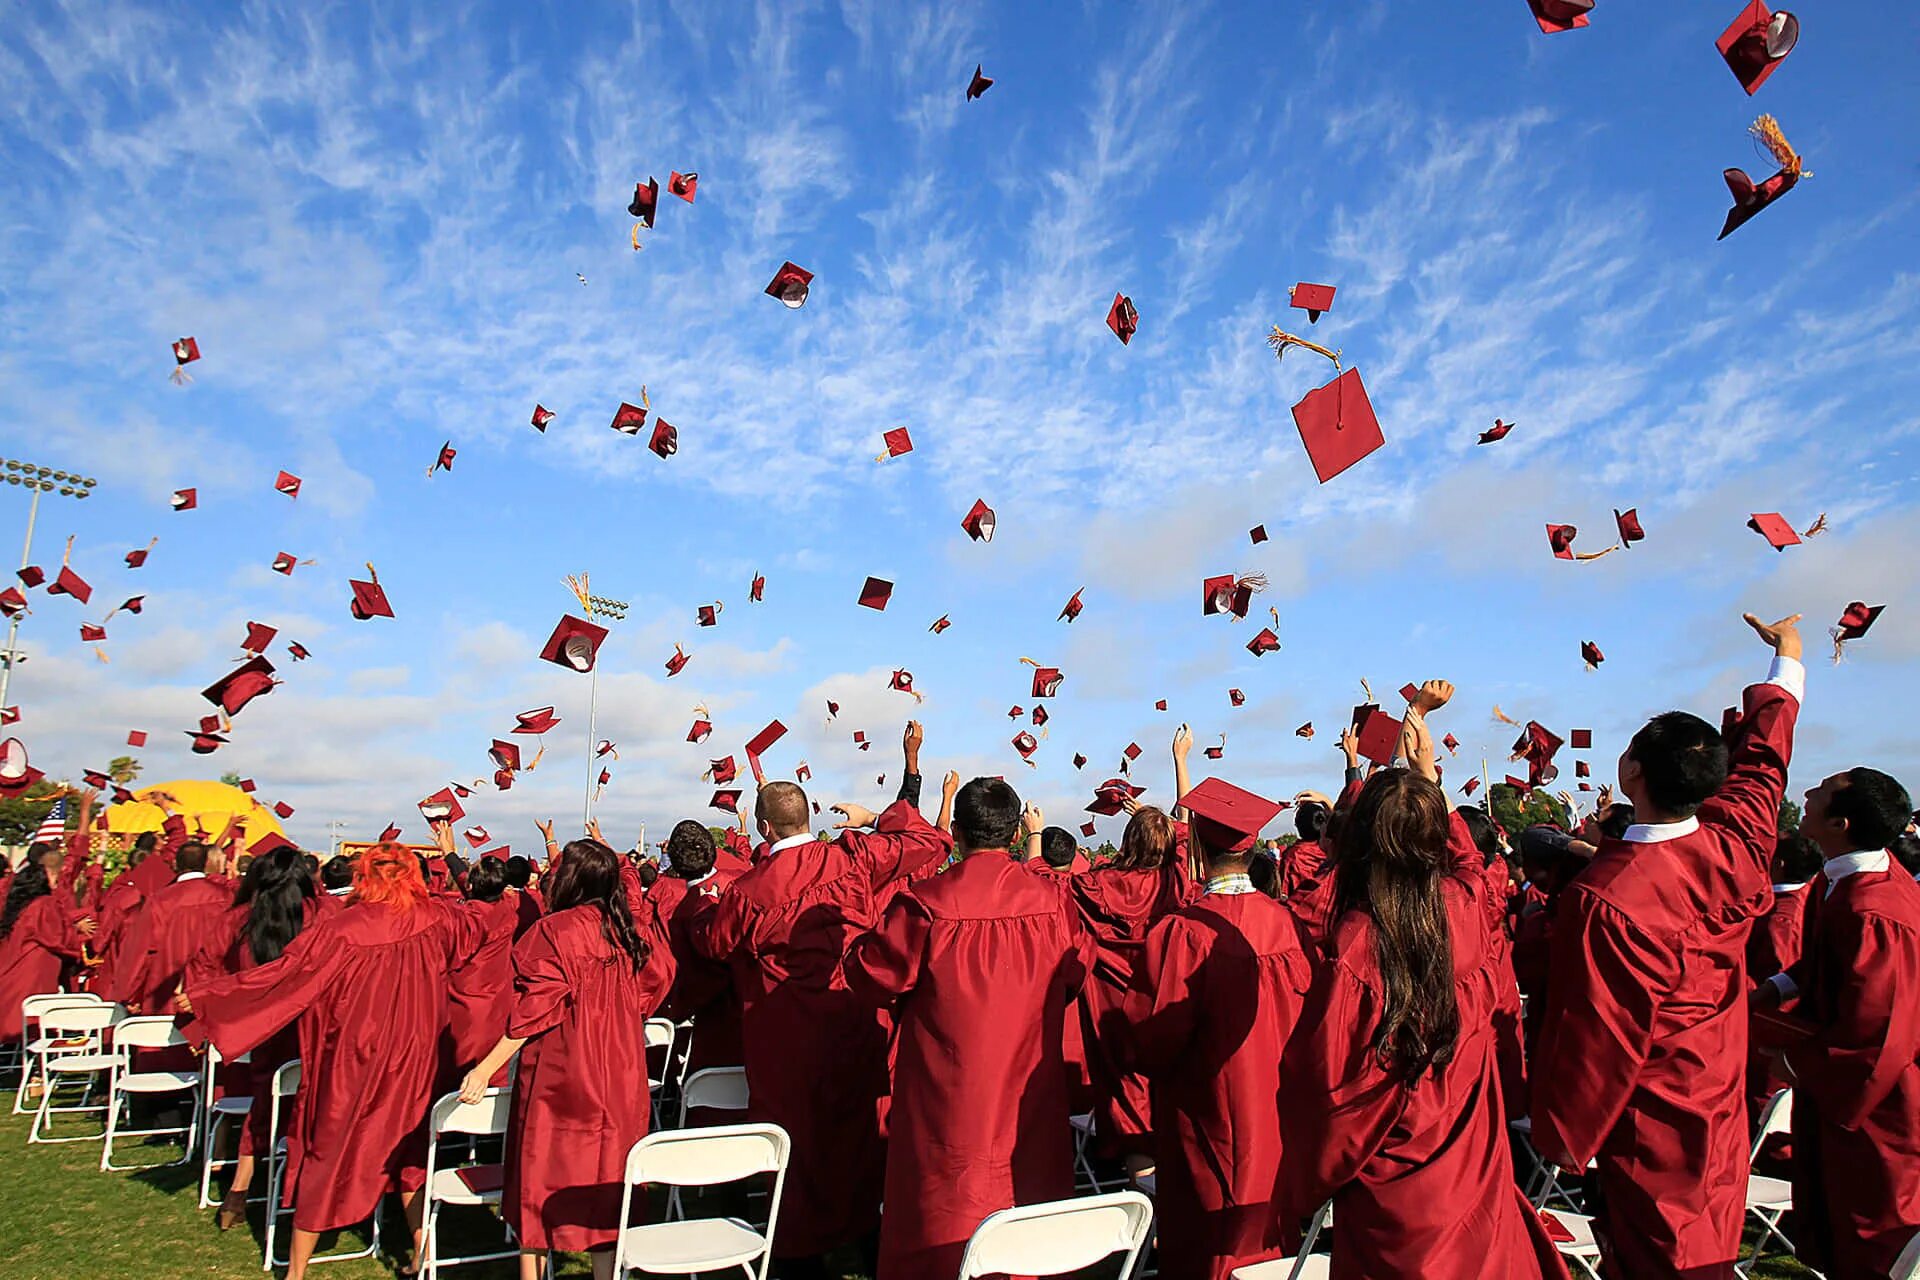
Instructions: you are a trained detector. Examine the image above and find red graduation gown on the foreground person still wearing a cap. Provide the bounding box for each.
[1133,892,1313,1280]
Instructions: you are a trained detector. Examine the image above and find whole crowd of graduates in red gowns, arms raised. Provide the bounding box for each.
[0,616,1920,1280]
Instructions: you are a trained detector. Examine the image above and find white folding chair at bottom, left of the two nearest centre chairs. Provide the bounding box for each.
[612,1125,793,1280]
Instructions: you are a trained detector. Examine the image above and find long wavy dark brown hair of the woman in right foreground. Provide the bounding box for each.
[1334,770,1459,1084]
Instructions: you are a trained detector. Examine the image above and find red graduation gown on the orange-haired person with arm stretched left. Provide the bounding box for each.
[186,898,482,1232]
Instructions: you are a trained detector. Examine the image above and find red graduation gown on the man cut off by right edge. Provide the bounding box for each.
[1788,864,1920,1280]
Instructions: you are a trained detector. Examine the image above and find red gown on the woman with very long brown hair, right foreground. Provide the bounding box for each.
[1279,818,1567,1280]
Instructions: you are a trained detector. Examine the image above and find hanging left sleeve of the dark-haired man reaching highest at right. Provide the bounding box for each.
[1528,885,1676,1169]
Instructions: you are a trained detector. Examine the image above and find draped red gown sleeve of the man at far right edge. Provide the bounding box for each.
[1788,909,1920,1128]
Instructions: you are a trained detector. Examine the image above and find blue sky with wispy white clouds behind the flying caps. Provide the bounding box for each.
[0,0,1920,846]
